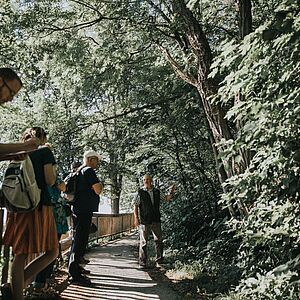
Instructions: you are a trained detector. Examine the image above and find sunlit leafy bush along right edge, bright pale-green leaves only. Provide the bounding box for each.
[212,1,300,299]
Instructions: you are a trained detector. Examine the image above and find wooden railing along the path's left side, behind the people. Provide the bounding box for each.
[0,208,134,283]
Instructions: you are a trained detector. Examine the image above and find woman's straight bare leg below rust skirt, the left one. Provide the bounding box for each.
[11,254,27,300]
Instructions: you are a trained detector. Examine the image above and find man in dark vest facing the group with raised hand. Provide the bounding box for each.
[134,175,175,267]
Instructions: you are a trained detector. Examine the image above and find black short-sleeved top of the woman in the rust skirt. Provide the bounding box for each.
[29,147,56,206]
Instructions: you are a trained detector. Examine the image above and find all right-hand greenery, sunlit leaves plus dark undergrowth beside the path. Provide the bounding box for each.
[163,1,300,300]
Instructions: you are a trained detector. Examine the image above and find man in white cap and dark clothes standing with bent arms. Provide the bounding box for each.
[69,150,103,286]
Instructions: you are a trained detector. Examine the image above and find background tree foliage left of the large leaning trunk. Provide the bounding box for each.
[0,1,219,227]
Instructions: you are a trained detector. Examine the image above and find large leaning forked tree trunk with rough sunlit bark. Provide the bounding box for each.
[170,0,235,183]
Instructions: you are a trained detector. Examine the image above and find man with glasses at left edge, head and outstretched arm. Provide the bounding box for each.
[0,68,39,160]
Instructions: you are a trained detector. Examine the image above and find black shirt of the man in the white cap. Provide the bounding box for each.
[73,167,100,214]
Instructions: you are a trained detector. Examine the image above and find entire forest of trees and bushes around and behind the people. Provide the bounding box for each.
[0,0,300,300]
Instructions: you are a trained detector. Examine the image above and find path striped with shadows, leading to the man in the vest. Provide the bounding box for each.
[61,235,182,300]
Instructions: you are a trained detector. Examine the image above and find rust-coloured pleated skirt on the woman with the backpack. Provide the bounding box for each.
[3,205,58,254]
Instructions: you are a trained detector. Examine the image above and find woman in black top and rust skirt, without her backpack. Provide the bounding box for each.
[1,127,59,300]
